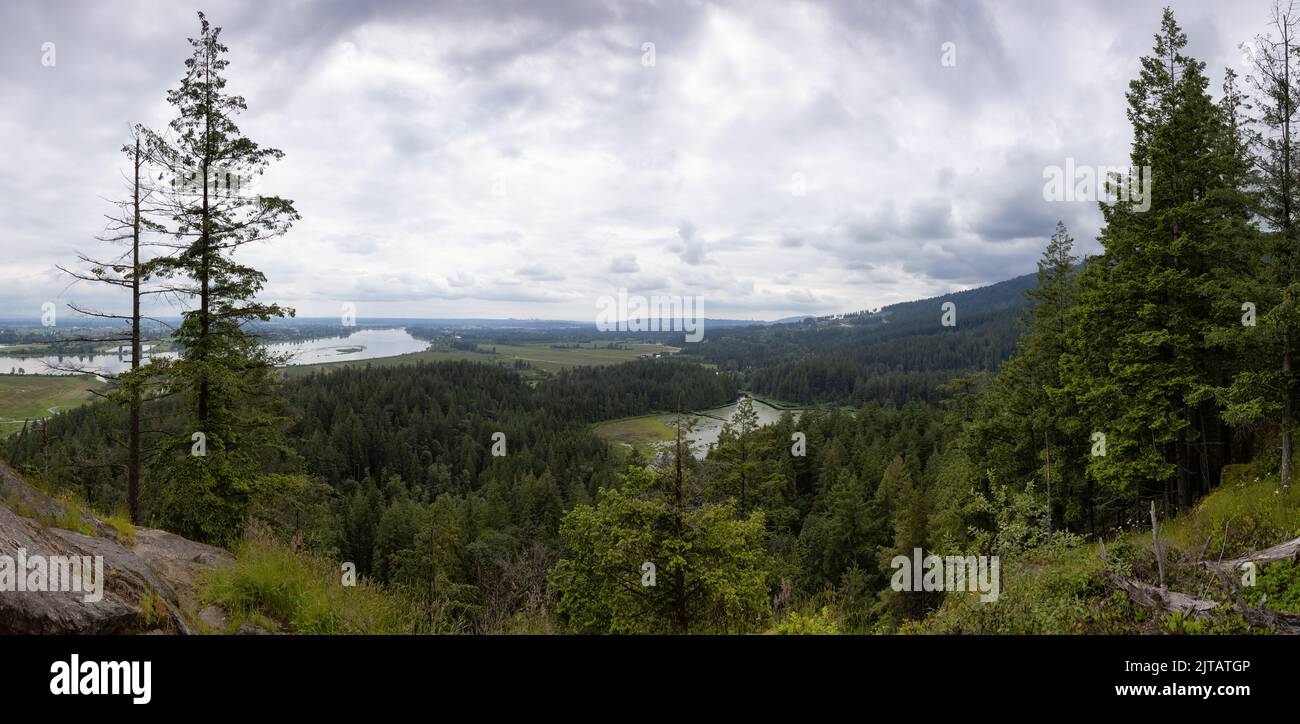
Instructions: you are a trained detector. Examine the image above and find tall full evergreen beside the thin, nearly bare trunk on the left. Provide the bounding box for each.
[150,13,298,541]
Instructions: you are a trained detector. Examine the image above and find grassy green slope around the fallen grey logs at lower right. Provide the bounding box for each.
[902,465,1300,634]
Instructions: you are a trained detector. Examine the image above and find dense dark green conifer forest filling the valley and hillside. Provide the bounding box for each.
[5,10,1300,633]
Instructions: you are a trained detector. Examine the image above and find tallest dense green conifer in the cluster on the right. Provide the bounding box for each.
[1063,10,1248,508]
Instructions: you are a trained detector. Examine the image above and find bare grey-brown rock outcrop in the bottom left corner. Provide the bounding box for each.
[0,464,230,634]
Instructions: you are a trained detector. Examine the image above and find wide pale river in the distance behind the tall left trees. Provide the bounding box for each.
[0,328,429,374]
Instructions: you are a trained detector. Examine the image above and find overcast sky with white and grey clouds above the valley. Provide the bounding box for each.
[0,0,1269,320]
